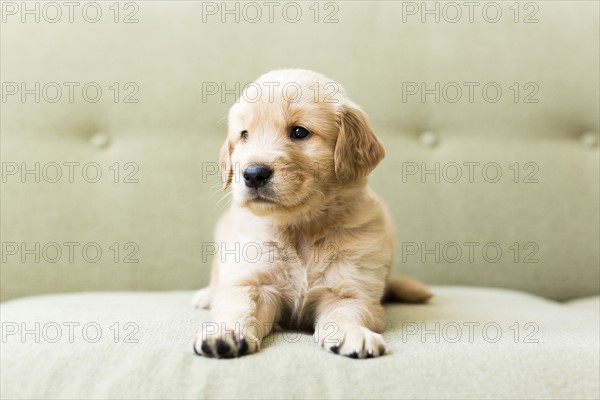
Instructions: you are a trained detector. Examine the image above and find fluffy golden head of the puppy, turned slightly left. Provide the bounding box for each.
[220,70,384,218]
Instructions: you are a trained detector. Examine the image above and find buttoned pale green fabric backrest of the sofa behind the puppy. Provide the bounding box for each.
[1,1,600,300]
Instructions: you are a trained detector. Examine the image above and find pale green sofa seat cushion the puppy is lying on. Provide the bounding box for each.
[0,287,600,399]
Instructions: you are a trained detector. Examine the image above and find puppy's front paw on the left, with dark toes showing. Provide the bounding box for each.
[193,329,260,358]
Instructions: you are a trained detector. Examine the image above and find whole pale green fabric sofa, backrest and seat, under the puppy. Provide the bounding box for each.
[0,1,600,399]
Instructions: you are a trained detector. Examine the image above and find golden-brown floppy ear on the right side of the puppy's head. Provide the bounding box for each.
[333,102,385,183]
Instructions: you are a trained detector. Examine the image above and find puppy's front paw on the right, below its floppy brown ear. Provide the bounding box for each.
[321,326,385,358]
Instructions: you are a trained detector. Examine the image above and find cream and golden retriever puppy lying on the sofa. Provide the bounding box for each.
[194,69,431,358]
